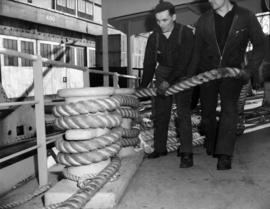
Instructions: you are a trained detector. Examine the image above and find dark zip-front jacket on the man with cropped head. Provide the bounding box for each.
[188,4,265,76]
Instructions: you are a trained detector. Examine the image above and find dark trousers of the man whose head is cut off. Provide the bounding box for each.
[200,78,242,156]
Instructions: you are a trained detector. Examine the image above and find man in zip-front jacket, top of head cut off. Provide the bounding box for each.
[189,0,264,170]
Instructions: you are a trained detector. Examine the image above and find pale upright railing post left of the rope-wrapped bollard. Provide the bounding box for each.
[33,55,48,186]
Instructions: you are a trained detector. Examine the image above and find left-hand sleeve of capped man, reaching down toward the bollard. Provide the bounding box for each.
[140,34,156,88]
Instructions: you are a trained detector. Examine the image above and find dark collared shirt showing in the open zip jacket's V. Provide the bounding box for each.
[214,7,235,52]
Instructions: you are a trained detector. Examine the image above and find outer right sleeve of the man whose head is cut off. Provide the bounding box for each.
[246,14,266,77]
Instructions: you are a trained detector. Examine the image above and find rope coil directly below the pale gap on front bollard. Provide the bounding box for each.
[55,128,122,153]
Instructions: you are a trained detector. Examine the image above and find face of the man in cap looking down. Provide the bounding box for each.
[155,10,176,33]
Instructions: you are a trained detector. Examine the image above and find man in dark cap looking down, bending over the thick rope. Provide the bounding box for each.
[140,1,193,168]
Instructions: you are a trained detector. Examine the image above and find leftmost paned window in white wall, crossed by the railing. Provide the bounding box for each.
[3,38,18,66]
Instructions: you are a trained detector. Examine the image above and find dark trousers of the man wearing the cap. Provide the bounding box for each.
[154,90,192,153]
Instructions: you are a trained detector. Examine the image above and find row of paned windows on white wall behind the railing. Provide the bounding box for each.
[0,37,95,67]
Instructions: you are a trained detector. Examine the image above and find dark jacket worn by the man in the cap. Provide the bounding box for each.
[140,23,194,87]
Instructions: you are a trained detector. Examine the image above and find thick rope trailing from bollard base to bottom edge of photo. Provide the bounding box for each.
[54,157,121,209]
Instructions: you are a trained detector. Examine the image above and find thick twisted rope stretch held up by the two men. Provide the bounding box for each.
[134,67,240,98]
